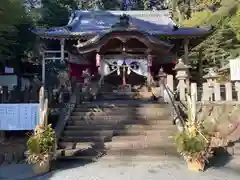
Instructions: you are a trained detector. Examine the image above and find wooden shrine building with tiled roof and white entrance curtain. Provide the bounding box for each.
[32,10,212,87]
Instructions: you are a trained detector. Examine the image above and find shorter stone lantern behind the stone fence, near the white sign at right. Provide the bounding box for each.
[203,68,221,101]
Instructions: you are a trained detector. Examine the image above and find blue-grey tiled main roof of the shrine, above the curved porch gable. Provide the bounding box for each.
[33,10,210,37]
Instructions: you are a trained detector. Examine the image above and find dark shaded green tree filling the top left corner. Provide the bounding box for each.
[0,0,34,60]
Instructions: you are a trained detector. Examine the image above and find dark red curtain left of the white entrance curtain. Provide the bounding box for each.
[68,63,97,82]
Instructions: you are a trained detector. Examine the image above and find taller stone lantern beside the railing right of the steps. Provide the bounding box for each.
[174,59,189,101]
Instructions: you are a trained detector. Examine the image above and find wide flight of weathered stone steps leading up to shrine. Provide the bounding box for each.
[57,100,178,159]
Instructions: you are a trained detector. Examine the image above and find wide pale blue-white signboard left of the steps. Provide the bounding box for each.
[0,104,39,131]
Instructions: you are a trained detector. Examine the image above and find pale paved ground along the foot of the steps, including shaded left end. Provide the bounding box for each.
[0,153,240,180]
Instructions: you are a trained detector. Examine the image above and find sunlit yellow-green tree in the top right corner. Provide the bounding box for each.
[178,0,240,65]
